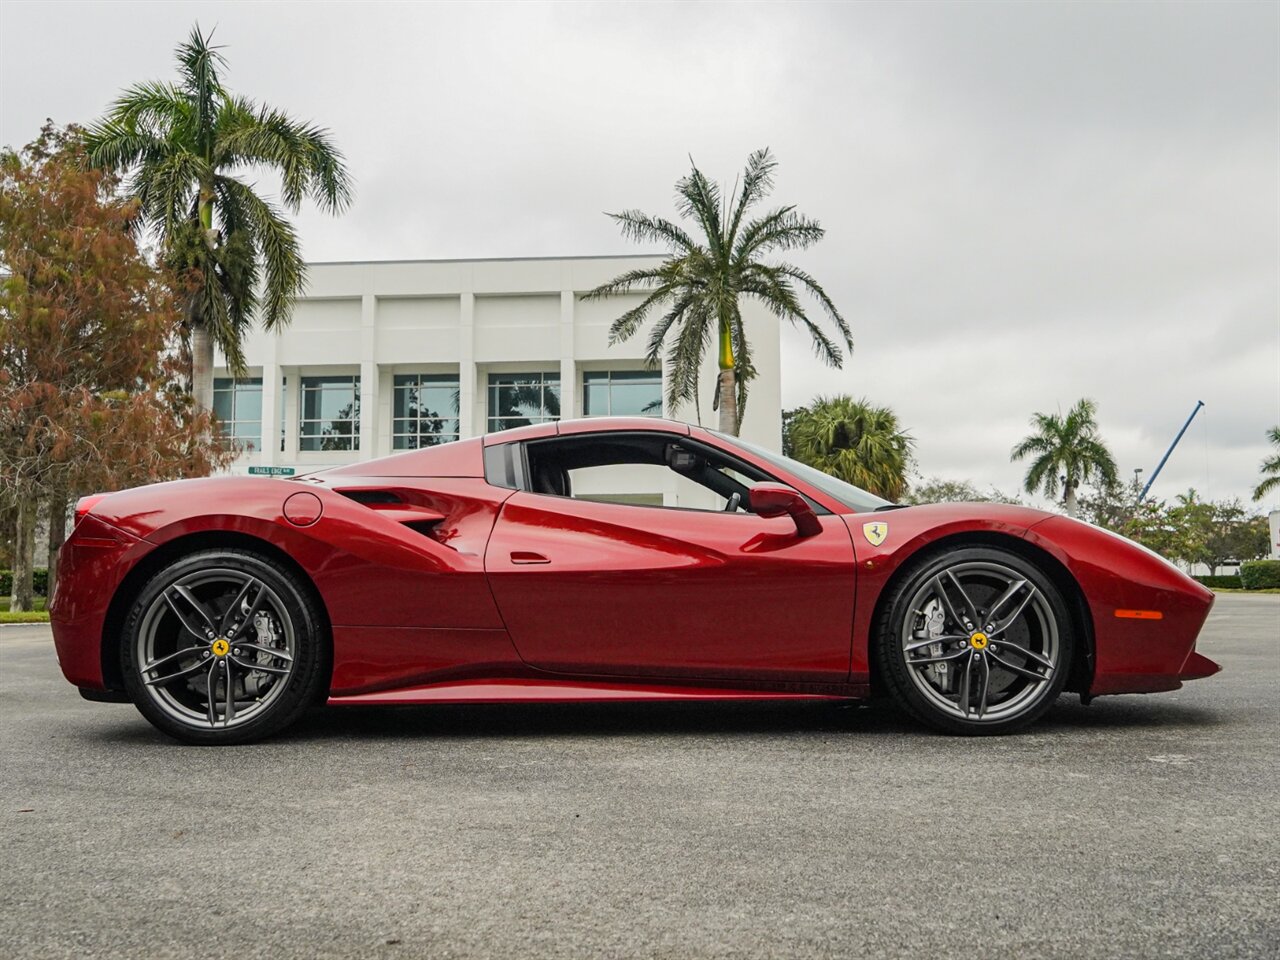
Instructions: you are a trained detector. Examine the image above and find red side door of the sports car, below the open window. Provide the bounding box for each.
[485,442,855,682]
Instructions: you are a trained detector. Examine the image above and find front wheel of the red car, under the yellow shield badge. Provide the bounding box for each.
[873,547,1075,736]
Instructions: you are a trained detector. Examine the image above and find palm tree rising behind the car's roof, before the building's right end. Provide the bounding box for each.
[586,148,854,434]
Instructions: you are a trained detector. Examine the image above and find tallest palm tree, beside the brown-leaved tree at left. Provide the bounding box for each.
[86,26,351,410]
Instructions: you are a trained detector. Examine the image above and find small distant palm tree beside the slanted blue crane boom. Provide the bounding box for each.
[1010,399,1116,517]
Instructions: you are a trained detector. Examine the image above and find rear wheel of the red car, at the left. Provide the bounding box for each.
[120,549,329,745]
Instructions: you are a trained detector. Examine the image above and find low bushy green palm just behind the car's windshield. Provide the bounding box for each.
[787,396,915,500]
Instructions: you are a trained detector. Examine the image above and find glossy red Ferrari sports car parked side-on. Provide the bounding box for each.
[50,419,1219,744]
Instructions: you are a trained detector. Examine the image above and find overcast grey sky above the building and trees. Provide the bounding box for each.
[0,0,1280,507]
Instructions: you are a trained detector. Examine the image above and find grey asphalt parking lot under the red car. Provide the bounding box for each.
[0,595,1280,957]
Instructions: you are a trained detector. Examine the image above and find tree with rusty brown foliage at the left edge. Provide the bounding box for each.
[0,125,230,611]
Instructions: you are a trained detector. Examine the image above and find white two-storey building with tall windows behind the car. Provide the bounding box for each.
[214,257,782,493]
